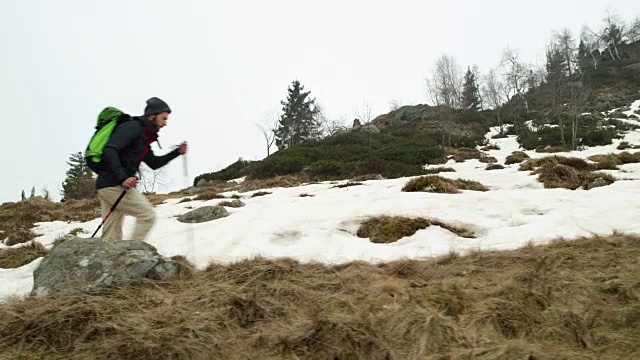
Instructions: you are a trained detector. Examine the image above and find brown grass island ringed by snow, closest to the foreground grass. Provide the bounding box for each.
[357,215,474,243]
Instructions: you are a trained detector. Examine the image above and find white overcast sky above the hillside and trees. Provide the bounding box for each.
[0,0,640,203]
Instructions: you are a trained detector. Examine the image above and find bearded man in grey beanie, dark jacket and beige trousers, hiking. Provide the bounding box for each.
[95,97,187,240]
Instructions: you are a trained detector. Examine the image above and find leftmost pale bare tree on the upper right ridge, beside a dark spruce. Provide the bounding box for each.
[425,54,463,109]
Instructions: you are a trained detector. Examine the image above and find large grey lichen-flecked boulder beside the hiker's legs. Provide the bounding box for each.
[31,237,182,296]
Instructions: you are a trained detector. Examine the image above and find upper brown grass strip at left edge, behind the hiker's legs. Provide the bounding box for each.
[0,197,100,245]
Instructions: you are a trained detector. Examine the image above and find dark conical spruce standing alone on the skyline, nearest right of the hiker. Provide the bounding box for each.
[275,80,319,149]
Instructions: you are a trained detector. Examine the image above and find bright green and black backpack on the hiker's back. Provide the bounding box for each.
[84,106,131,171]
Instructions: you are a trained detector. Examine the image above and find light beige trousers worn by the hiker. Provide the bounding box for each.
[97,186,156,240]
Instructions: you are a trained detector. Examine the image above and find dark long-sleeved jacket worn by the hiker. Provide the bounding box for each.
[94,116,180,189]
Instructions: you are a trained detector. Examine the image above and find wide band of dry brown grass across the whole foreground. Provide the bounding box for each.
[0,234,640,360]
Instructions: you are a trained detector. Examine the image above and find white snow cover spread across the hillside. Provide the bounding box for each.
[0,100,640,299]
